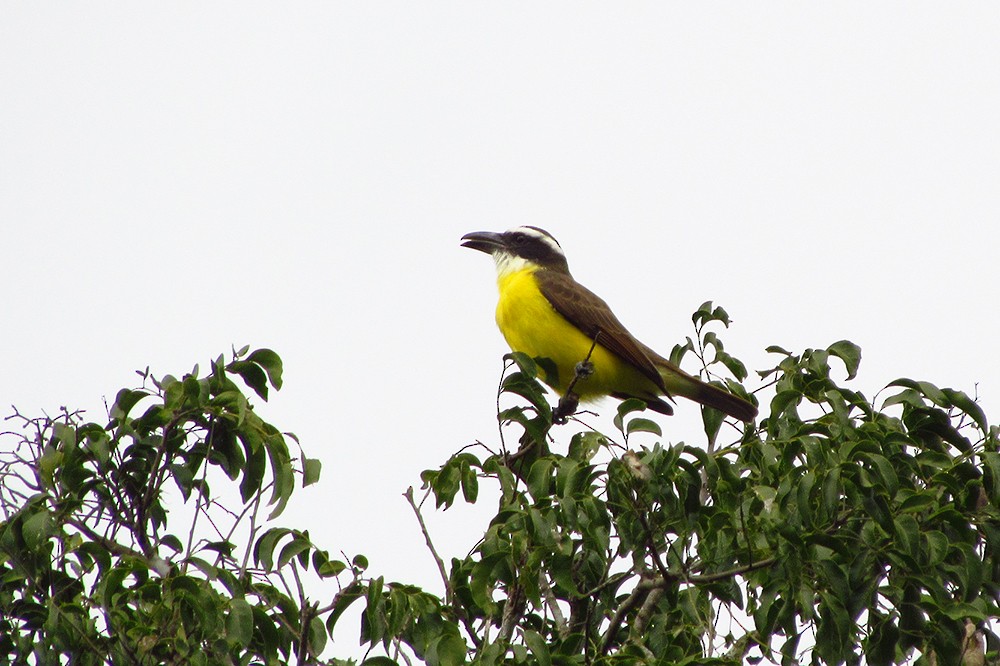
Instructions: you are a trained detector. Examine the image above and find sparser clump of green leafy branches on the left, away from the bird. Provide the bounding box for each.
[0,349,361,665]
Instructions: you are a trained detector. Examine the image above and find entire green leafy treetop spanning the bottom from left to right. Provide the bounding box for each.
[0,303,1000,665]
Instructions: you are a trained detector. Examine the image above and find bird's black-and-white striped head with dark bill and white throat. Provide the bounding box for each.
[462,226,569,277]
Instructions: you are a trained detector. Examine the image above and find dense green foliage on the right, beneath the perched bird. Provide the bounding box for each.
[414,303,1000,664]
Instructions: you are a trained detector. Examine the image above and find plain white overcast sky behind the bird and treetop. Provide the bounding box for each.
[0,2,1000,652]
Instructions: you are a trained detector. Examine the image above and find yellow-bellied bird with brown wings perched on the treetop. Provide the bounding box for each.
[461,226,757,422]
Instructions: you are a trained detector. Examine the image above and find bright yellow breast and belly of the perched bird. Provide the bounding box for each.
[496,268,659,398]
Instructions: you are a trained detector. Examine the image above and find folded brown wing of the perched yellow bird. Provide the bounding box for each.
[535,270,667,393]
